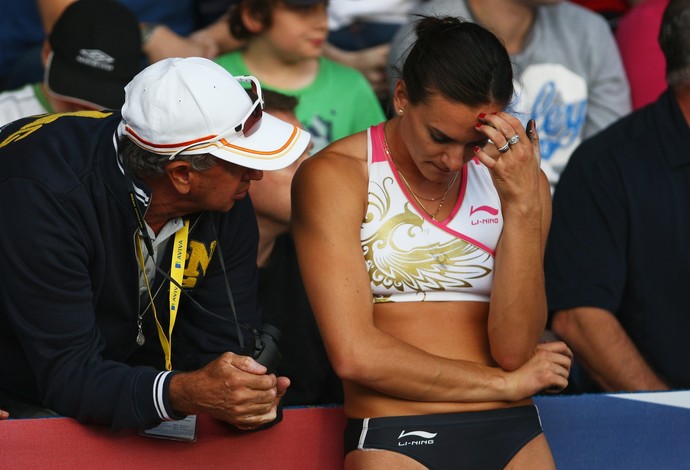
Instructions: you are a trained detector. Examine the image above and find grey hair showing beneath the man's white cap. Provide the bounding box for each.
[119,137,218,179]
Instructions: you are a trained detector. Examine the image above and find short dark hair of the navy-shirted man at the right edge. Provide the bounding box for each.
[659,0,690,86]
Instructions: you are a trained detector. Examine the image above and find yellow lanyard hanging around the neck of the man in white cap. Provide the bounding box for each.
[137,220,189,370]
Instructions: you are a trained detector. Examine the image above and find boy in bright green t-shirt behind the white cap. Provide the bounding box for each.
[216,0,385,152]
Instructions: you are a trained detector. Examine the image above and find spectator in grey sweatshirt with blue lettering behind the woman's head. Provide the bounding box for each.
[389,0,631,189]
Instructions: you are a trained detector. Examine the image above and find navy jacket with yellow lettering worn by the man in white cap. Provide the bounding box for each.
[0,112,260,429]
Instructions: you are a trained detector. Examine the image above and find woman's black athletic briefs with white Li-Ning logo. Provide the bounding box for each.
[345,405,543,470]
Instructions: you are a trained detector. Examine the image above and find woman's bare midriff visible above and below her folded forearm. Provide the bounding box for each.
[343,302,531,418]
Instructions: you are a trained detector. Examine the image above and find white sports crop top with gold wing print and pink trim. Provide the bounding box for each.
[361,123,503,303]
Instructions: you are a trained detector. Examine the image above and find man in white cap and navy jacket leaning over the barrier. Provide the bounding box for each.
[0,58,309,429]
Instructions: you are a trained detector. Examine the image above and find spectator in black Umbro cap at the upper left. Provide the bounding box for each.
[0,0,141,125]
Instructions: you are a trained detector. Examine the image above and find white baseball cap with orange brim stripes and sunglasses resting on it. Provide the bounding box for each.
[120,57,310,170]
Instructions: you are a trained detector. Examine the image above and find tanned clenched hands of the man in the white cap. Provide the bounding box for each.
[170,352,290,430]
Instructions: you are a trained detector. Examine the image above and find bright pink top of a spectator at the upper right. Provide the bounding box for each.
[616,0,668,109]
